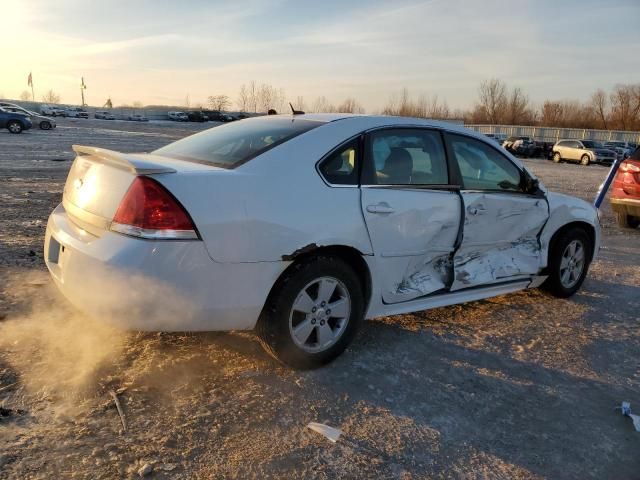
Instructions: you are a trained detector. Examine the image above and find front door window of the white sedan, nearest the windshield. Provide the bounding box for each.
[448,135,523,192]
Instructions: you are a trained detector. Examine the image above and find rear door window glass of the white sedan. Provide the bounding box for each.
[363,129,449,185]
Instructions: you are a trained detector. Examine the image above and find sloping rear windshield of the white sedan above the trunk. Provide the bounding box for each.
[153,116,323,168]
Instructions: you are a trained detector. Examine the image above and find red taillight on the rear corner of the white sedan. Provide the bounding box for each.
[111,177,198,240]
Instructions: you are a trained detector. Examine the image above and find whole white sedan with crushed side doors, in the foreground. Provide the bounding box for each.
[45,114,600,368]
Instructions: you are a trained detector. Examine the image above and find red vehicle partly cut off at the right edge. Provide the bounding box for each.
[609,148,640,228]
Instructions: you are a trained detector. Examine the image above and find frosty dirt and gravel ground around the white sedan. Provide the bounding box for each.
[0,120,640,479]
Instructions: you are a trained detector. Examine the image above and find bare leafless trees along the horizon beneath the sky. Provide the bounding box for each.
[21,78,640,131]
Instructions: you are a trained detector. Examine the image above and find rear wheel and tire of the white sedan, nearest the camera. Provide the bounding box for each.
[256,255,364,369]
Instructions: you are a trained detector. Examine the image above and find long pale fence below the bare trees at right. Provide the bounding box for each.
[465,125,640,144]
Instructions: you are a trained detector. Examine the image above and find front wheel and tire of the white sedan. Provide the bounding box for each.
[541,227,593,298]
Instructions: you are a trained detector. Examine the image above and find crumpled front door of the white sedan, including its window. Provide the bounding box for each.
[447,134,549,291]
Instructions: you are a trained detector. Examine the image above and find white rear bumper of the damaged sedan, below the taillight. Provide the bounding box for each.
[44,205,287,331]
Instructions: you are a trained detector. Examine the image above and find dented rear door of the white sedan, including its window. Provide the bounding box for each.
[361,128,462,303]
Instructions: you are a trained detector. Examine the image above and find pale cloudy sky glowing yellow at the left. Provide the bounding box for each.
[0,0,640,112]
